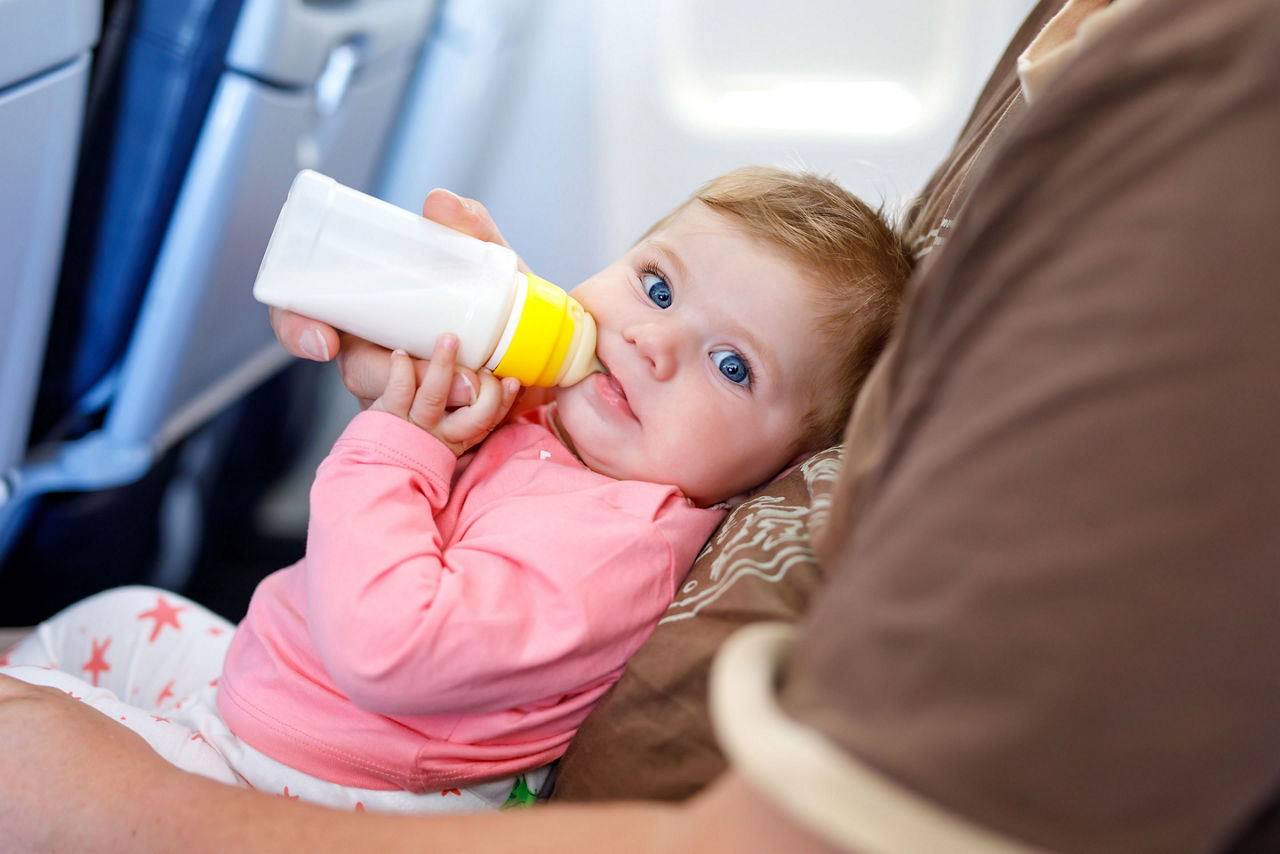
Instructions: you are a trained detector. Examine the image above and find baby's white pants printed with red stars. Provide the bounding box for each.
[0,586,545,813]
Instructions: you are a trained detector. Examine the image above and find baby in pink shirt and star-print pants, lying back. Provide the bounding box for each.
[0,168,910,812]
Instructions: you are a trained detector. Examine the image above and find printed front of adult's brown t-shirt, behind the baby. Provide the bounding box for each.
[553,0,1061,800]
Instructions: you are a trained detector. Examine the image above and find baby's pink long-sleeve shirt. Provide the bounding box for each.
[218,408,723,791]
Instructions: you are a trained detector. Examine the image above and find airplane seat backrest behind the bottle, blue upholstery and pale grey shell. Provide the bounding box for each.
[0,0,434,578]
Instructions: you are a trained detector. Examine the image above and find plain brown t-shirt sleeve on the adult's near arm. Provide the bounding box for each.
[782,0,1280,853]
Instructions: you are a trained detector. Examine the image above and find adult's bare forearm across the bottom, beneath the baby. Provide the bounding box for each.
[0,676,849,854]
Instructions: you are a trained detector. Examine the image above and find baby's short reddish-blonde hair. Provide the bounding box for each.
[645,166,911,449]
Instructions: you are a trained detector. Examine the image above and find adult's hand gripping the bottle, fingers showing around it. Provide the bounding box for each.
[269,189,529,408]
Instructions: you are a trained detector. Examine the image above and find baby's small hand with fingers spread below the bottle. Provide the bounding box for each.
[369,334,520,456]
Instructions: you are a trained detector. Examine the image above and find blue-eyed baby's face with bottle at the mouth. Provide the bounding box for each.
[556,202,824,506]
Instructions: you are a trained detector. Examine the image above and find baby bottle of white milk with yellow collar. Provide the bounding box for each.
[253,170,603,385]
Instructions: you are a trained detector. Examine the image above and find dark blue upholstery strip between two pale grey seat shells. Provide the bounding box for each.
[32,0,242,440]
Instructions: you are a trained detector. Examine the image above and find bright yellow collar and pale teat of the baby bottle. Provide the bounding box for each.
[493,274,595,385]
